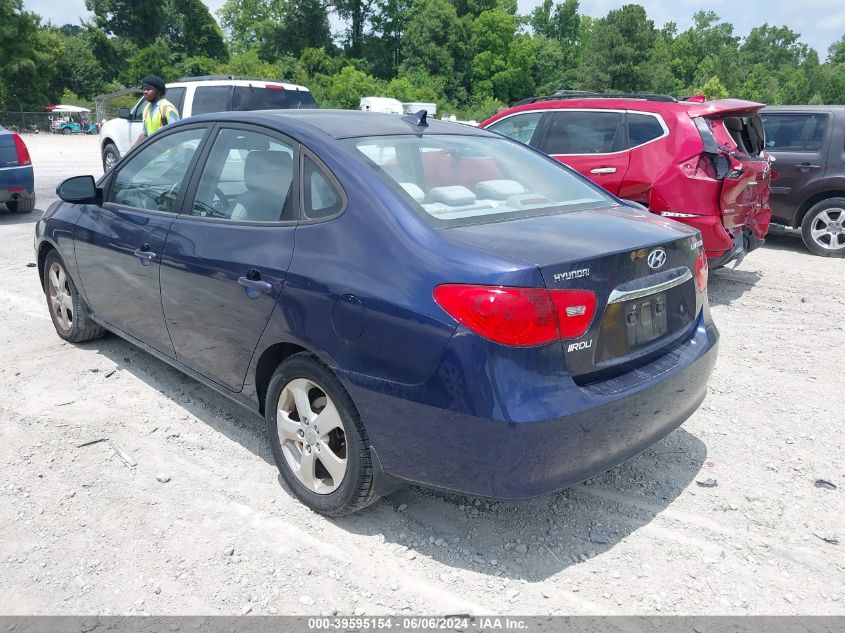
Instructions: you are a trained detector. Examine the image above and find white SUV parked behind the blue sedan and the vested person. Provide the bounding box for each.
[100,75,319,171]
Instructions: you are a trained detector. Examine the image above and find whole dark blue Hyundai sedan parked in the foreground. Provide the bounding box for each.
[35,110,718,516]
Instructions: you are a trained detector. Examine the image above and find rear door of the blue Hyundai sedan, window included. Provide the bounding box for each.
[161,124,298,391]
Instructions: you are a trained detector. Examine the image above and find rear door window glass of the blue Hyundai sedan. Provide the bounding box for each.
[191,129,295,222]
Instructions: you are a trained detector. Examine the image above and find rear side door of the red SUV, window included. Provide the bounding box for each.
[538,109,630,194]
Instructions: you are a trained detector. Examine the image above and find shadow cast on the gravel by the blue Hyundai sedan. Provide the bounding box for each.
[83,336,707,581]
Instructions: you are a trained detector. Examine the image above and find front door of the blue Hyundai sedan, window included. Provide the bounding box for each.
[75,125,208,357]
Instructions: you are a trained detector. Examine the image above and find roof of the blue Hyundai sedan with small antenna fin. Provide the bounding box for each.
[198,109,499,139]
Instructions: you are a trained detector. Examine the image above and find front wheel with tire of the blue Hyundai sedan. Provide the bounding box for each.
[44,251,106,343]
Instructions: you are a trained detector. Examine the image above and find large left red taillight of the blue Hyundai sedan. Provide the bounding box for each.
[434,284,596,347]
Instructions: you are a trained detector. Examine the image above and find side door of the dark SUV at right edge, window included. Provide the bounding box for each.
[761,110,830,225]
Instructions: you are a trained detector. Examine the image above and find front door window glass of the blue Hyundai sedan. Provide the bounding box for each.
[106,128,205,213]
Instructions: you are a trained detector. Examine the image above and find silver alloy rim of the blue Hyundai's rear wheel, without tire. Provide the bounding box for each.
[276,378,347,495]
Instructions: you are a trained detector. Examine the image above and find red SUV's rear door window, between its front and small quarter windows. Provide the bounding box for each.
[541,110,624,154]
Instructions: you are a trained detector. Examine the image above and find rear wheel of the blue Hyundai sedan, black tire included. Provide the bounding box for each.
[265,352,376,516]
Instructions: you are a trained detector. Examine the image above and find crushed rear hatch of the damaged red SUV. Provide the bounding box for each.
[688,99,771,240]
